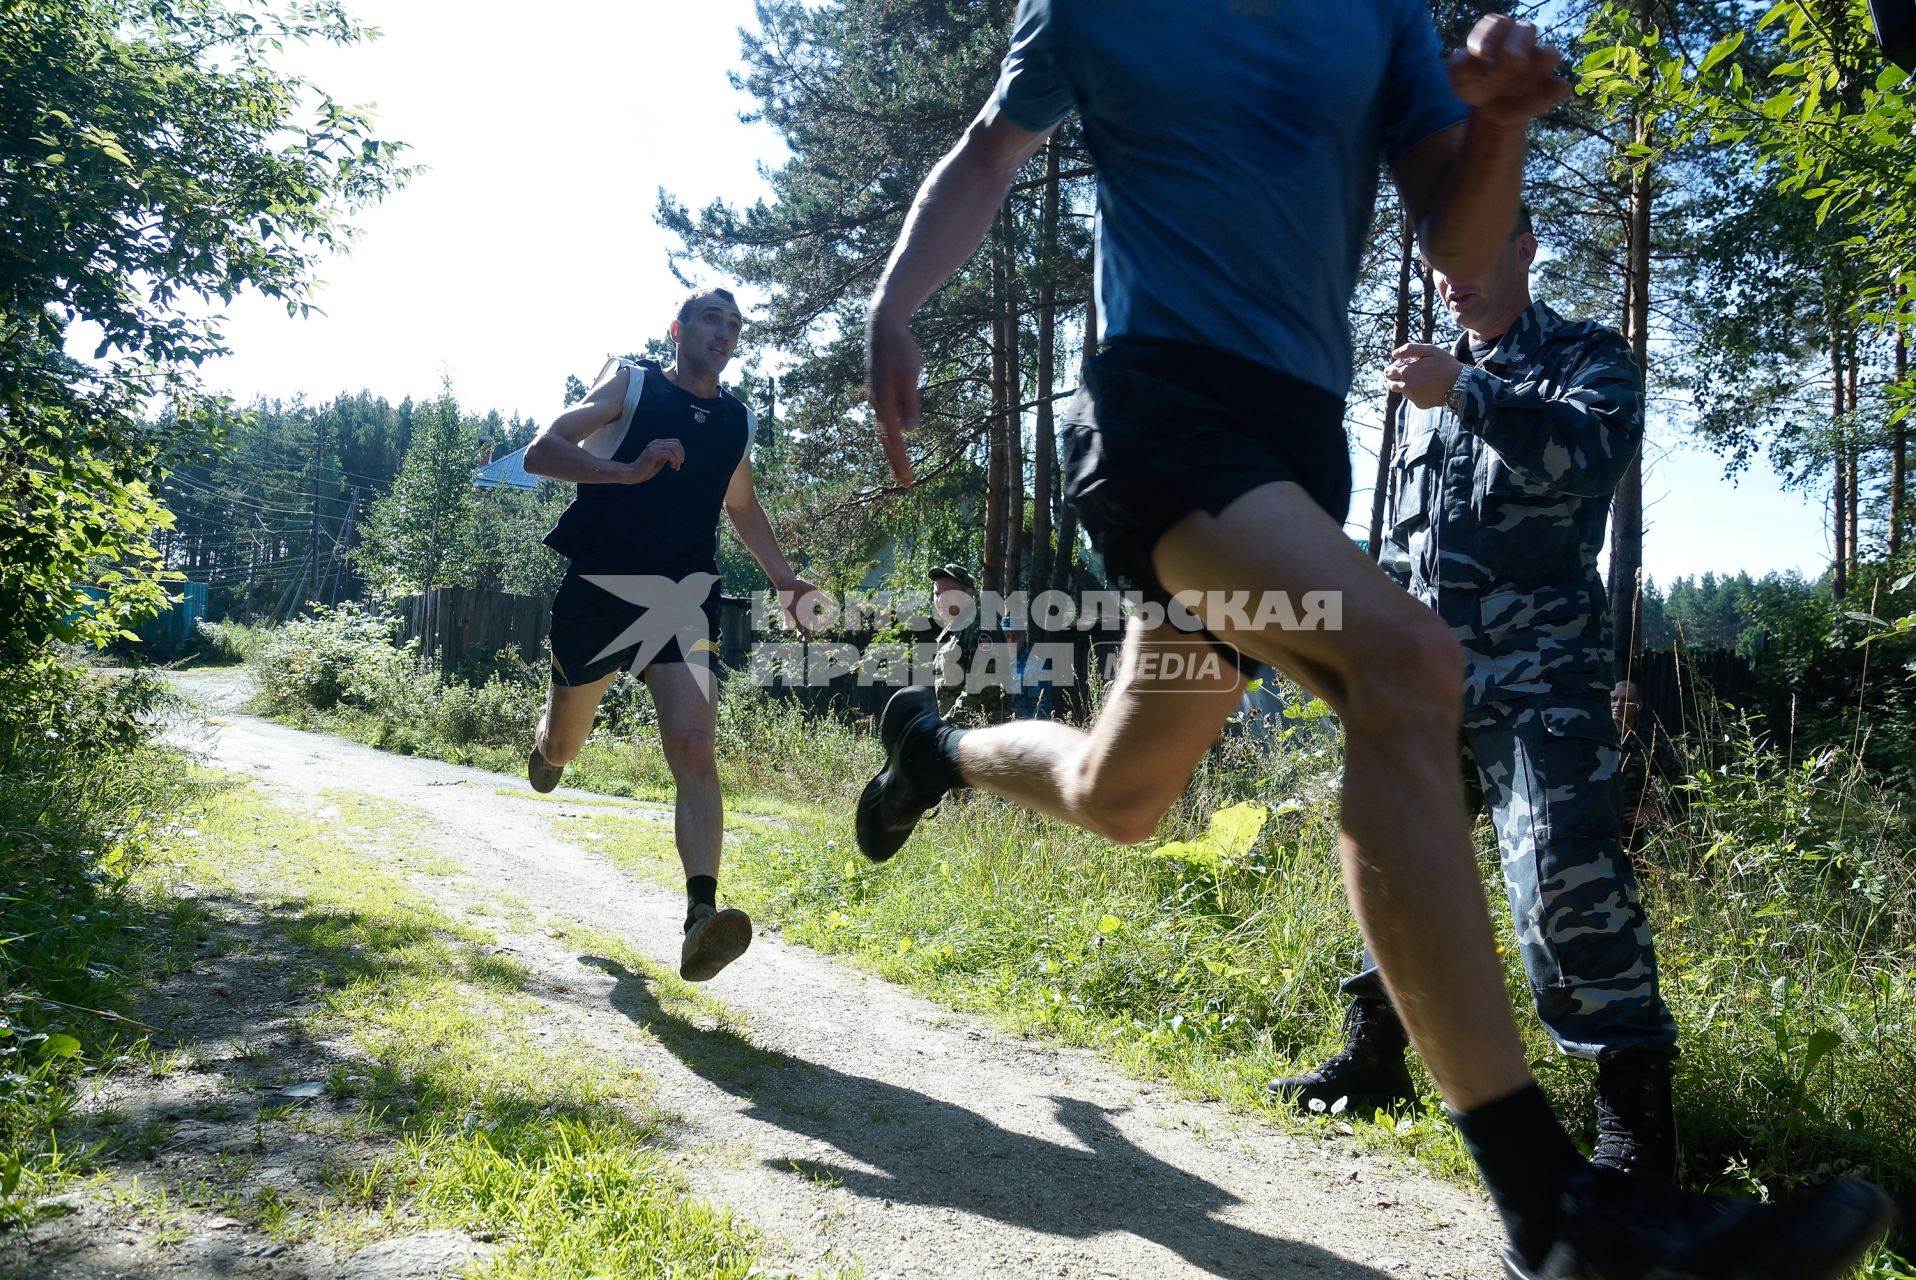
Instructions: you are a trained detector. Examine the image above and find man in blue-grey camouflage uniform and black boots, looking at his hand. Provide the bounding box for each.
[1272,211,1677,1180]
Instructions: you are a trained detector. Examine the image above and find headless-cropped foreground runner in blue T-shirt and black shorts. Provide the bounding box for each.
[856,0,1893,1280]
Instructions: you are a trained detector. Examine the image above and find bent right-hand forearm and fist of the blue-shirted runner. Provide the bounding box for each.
[1391,13,1569,280]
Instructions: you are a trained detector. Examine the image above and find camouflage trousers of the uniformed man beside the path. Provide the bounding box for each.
[1343,694,1677,1058]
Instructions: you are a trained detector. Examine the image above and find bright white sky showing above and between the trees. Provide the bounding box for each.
[164,0,1828,583]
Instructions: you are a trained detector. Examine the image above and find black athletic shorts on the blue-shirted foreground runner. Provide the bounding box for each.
[1061,337,1351,651]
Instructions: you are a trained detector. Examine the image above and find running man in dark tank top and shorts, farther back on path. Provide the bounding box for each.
[525,289,812,981]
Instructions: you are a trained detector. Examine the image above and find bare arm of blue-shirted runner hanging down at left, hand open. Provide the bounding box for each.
[866,96,1048,485]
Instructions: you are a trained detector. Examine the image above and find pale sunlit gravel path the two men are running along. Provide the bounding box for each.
[149,671,1500,1280]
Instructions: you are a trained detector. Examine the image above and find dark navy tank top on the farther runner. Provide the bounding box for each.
[546,362,751,577]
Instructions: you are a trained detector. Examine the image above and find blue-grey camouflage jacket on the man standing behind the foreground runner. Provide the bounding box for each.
[1383,303,1644,707]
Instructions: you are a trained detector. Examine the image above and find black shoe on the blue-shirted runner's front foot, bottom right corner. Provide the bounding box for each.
[1504,1169,1895,1280]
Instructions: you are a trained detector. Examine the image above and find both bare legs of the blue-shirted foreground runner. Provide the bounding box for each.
[958,483,1531,1111]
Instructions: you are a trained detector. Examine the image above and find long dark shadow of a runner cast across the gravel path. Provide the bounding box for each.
[581,956,1410,1280]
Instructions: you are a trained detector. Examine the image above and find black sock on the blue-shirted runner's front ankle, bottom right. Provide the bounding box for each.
[1450,1085,1586,1267]
